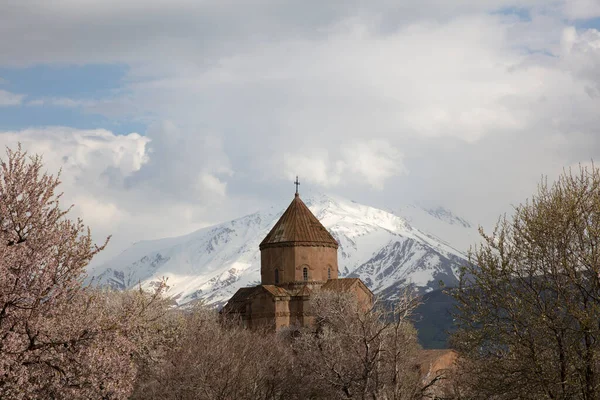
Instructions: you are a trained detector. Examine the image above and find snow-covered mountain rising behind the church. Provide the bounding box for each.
[88,195,476,304]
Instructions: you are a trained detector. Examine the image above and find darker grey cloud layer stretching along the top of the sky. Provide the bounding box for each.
[0,0,572,67]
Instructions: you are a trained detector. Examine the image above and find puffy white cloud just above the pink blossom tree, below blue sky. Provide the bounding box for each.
[0,127,148,232]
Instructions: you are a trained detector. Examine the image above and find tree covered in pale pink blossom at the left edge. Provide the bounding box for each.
[0,147,169,399]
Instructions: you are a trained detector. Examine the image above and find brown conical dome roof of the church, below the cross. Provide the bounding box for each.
[259,193,338,250]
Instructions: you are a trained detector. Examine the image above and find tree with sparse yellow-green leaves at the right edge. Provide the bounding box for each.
[453,166,600,399]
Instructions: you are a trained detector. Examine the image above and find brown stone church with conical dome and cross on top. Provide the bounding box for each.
[222,188,373,330]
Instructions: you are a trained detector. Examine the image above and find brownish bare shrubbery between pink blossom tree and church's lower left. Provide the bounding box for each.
[133,305,292,400]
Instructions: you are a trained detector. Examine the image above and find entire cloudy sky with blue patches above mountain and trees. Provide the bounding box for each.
[0,0,600,266]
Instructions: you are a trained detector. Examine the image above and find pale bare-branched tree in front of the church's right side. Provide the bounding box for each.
[295,291,422,399]
